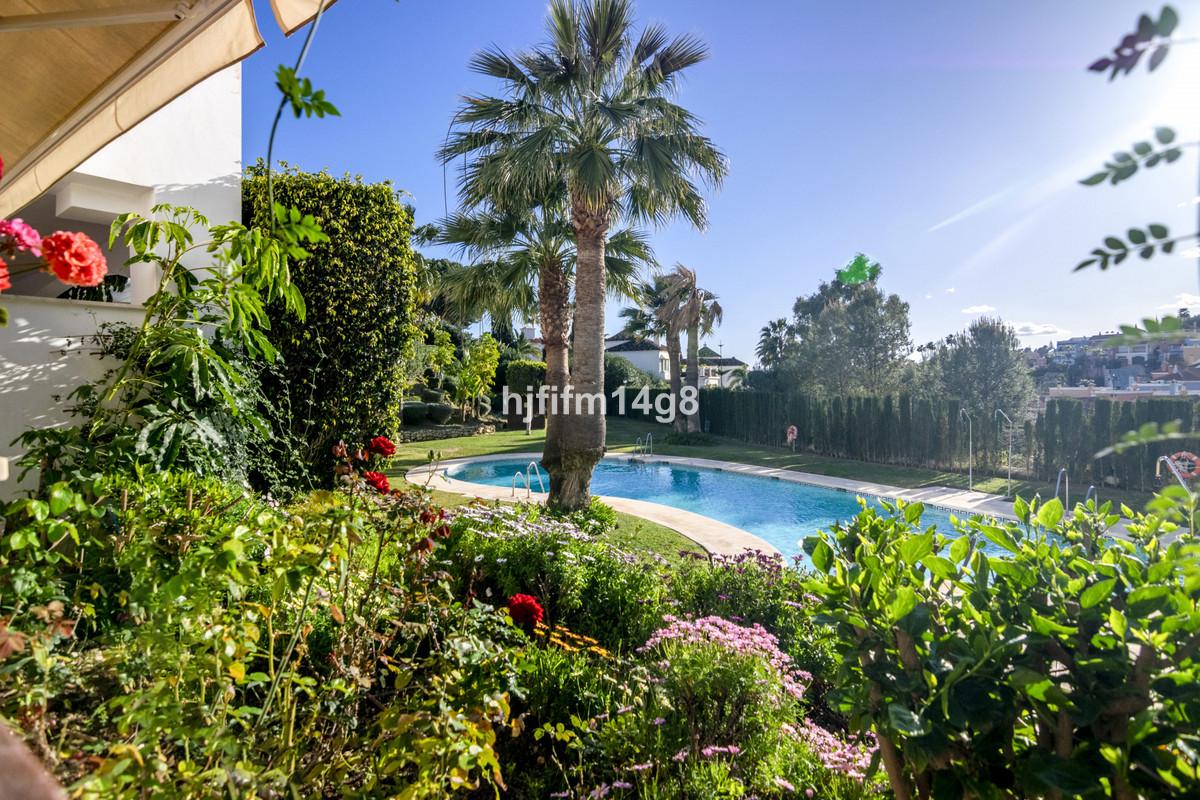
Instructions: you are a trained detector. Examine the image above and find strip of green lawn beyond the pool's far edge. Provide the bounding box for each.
[394,417,1151,515]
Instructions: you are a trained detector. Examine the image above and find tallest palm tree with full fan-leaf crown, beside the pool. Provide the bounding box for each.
[440,0,727,510]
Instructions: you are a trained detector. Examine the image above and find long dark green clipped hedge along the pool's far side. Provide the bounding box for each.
[608,389,1200,498]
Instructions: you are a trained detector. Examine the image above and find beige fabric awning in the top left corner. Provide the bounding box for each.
[0,0,328,218]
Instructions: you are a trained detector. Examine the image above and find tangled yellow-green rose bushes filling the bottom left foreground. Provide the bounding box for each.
[0,473,518,800]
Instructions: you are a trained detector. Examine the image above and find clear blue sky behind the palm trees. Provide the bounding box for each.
[244,0,1200,361]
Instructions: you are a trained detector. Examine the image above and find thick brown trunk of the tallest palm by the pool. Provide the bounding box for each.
[542,200,608,511]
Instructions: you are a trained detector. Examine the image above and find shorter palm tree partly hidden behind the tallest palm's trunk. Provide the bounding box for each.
[438,204,655,470]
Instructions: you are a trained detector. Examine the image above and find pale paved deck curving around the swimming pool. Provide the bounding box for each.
[404,452,1036,555]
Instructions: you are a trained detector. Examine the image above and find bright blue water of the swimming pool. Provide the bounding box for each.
[448,458,988,557]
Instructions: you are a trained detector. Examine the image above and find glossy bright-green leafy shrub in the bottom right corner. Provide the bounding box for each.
[804,489,1200,798]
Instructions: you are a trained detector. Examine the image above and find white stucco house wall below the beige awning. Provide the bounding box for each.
[0,66,241,499]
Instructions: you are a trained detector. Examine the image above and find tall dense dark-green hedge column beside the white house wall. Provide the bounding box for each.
[242,162,420,463]
